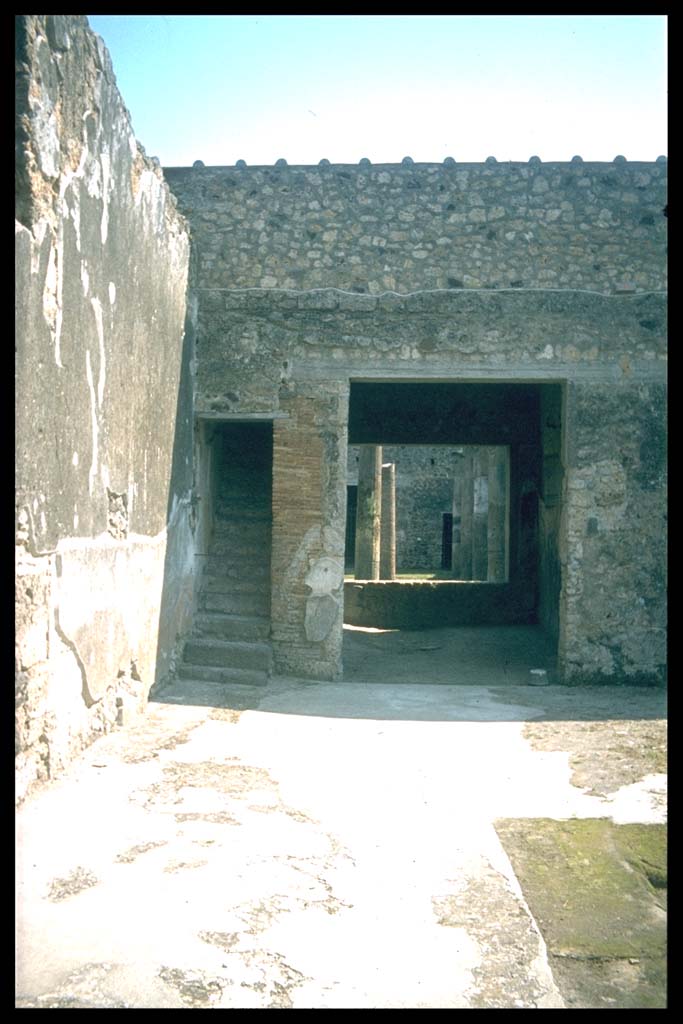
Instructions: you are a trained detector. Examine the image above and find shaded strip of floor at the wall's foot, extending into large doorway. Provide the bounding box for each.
[155,626,667,722]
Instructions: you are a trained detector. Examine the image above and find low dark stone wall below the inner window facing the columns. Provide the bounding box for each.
[344,580,536,630]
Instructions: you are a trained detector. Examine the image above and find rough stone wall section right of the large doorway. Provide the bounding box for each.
[560,380,667,682]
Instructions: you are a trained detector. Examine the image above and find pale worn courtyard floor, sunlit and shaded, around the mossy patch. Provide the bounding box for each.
[16,628,666,1009]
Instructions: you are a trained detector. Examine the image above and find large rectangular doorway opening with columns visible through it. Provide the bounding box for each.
[344,382,562,640]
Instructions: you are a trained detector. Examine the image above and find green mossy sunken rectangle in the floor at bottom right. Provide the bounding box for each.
[496,818,667,1008]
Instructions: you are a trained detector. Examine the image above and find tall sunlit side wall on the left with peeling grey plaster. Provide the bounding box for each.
[15,15,195,799]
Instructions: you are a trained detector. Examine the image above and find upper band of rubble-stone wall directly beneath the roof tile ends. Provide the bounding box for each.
[165,162,667,295]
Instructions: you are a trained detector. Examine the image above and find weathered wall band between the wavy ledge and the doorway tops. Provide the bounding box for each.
[184,278,667,415]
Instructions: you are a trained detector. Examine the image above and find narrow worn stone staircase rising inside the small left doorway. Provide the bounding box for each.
[178,442,271,686]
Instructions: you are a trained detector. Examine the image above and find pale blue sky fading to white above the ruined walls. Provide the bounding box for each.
[88,14,668,167]
